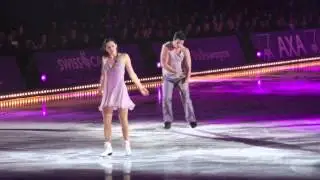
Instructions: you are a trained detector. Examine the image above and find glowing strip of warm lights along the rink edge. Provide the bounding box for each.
[0,57,320,108]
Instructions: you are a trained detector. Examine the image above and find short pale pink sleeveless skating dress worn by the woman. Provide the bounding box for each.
[99,54,135,111]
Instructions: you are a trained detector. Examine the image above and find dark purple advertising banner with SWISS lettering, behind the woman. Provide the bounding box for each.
[35,45,142,88]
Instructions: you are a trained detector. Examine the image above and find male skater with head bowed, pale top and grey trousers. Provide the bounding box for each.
[160,31,197,129]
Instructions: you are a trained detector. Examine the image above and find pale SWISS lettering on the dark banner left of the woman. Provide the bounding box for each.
[57,51,101,72]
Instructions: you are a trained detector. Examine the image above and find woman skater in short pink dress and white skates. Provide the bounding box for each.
[99,39,149,156]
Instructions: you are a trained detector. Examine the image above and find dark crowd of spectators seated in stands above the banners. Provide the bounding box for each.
[0,0,320,54]
